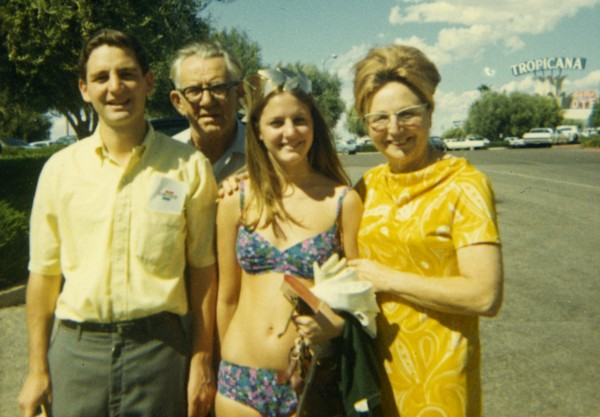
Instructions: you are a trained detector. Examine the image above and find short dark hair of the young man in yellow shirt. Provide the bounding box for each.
[79,29,150,81]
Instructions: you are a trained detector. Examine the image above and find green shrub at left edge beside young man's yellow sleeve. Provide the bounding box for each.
[0,201,29,289]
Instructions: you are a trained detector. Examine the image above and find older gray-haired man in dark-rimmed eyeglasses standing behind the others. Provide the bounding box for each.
[170,41,245,182]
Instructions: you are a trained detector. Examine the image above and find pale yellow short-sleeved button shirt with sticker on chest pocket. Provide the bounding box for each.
[29,126,217,322]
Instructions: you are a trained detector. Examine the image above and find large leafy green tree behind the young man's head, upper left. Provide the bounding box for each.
[0,0,226,137]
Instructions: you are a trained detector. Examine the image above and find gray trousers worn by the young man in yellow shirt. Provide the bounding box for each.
[48,316,189,417]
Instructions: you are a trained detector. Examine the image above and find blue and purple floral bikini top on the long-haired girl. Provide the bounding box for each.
[236,182,350,279]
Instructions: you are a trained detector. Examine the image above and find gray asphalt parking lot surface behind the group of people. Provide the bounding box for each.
[0,147,600,417]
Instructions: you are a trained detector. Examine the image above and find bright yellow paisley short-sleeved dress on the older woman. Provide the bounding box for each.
[358,155,500,417]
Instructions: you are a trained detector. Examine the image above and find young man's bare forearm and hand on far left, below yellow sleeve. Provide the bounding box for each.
[19,273,61,417]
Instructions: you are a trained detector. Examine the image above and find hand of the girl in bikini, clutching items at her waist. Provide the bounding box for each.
[294,303,345,346]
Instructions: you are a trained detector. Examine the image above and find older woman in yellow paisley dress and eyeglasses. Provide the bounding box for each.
[349,45,503,417]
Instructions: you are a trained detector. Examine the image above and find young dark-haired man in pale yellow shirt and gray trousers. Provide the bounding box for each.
[19,29,217,417]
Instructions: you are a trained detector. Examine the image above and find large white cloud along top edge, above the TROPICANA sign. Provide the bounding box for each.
[388,0,600,64]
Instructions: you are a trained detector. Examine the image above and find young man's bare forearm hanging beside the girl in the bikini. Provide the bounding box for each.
[188,264,217,417]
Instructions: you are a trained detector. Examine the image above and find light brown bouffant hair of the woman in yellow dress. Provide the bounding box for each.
[354,45,442,116]
